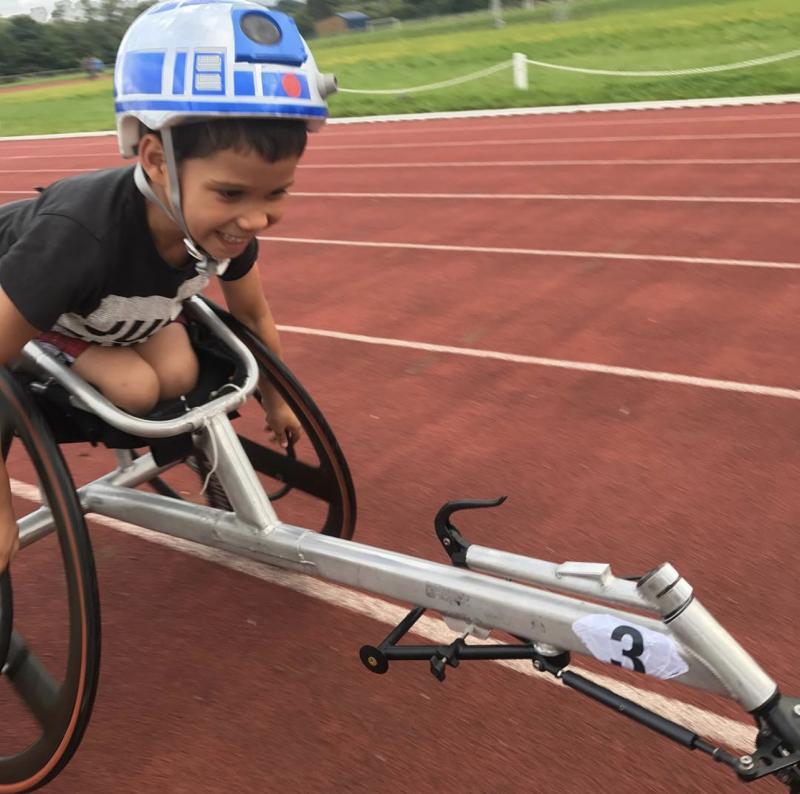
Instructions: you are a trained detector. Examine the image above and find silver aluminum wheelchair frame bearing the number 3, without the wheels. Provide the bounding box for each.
[0,299,800,792]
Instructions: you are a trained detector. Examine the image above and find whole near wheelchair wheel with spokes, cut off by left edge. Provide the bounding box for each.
[0,369,100,794]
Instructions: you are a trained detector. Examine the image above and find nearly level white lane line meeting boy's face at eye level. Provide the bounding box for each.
[291,190,800,204]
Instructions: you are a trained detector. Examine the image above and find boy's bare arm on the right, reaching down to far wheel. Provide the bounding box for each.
[220,267,302,447]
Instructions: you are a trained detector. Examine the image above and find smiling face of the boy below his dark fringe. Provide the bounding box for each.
[141,136,299,264]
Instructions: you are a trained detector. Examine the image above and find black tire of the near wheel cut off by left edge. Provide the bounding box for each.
[0,368,100,794]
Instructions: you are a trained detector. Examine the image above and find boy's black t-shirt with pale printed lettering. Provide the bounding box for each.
[0,168,258,345]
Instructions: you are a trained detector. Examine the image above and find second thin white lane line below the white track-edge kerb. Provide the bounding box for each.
[310,132,798,156]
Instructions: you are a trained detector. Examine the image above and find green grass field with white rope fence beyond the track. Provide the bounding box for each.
[0,0,800,135]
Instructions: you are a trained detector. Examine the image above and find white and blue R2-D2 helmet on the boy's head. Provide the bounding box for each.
[114,0,336,157]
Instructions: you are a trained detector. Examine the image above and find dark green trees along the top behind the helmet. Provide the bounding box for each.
[0,0,494,82]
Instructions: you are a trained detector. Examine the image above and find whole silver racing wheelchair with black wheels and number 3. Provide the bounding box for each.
[0,298,800,794]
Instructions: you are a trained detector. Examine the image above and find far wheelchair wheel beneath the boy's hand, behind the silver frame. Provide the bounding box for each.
[150,301,356,538]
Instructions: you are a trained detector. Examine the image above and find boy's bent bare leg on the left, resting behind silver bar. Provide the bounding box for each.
[72,345,159,415]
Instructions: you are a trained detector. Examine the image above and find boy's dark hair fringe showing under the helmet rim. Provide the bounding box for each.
[142,118,308,164]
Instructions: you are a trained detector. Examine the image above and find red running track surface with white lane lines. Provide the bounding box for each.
[0,105,800,794]
